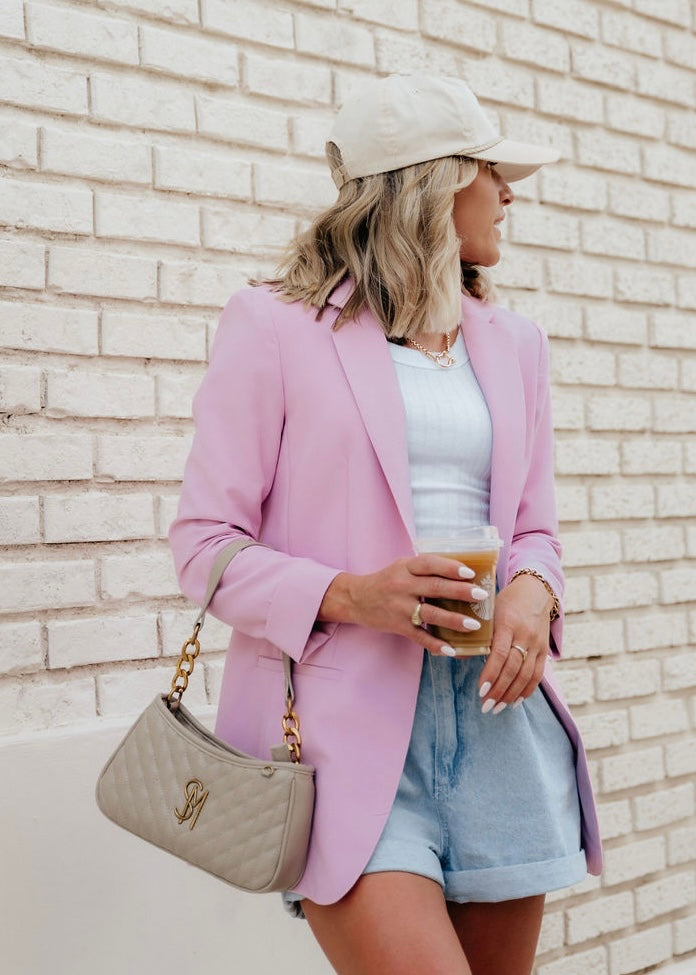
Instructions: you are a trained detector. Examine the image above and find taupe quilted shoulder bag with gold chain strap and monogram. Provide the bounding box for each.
[96,539,314,893]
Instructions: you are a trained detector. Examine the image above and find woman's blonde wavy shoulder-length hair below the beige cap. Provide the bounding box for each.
[251,142,493,341]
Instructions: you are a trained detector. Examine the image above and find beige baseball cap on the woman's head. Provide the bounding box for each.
[327,74,560,189]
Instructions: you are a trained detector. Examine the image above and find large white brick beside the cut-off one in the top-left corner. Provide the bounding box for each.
[25,3,138,64]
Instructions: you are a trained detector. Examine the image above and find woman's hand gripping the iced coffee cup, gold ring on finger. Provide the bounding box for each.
[317,554,487,657]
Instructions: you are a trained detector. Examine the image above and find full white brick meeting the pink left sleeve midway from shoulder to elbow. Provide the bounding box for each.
[97,434,191,481]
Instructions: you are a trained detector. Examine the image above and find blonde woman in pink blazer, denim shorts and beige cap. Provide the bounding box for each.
[170,77,601,975]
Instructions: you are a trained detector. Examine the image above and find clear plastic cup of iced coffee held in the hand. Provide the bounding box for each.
[416,525,503,657]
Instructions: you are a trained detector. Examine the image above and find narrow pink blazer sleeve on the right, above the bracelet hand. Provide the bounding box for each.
[507,326,564,657]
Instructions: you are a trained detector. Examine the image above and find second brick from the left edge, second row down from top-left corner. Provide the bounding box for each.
[90,72,196,133]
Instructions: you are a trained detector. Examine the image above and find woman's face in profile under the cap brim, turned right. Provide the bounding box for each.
[453,159,515,267]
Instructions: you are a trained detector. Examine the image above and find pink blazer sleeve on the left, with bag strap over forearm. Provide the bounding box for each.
[169,289,340,662]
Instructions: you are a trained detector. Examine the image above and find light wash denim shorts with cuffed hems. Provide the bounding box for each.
[282,651,586,918]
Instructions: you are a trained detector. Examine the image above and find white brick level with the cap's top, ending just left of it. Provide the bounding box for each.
[244,51,331,106]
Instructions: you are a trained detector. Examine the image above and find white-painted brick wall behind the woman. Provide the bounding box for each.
[0,0,696,975]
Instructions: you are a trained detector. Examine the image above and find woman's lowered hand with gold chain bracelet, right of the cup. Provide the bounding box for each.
[479,575,553,714]
